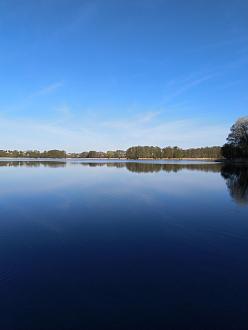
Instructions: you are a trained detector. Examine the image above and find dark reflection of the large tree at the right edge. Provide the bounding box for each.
[221,165,248,204]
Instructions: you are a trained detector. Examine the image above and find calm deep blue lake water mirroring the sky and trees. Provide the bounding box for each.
[0,161,248,330]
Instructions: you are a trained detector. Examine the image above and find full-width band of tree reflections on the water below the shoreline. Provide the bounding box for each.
[0,160,248,205]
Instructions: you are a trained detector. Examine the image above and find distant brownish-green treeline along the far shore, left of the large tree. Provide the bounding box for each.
[0,146,222,159]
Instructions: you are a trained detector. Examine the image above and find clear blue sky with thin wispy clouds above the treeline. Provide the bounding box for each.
[0,0,248,152]
